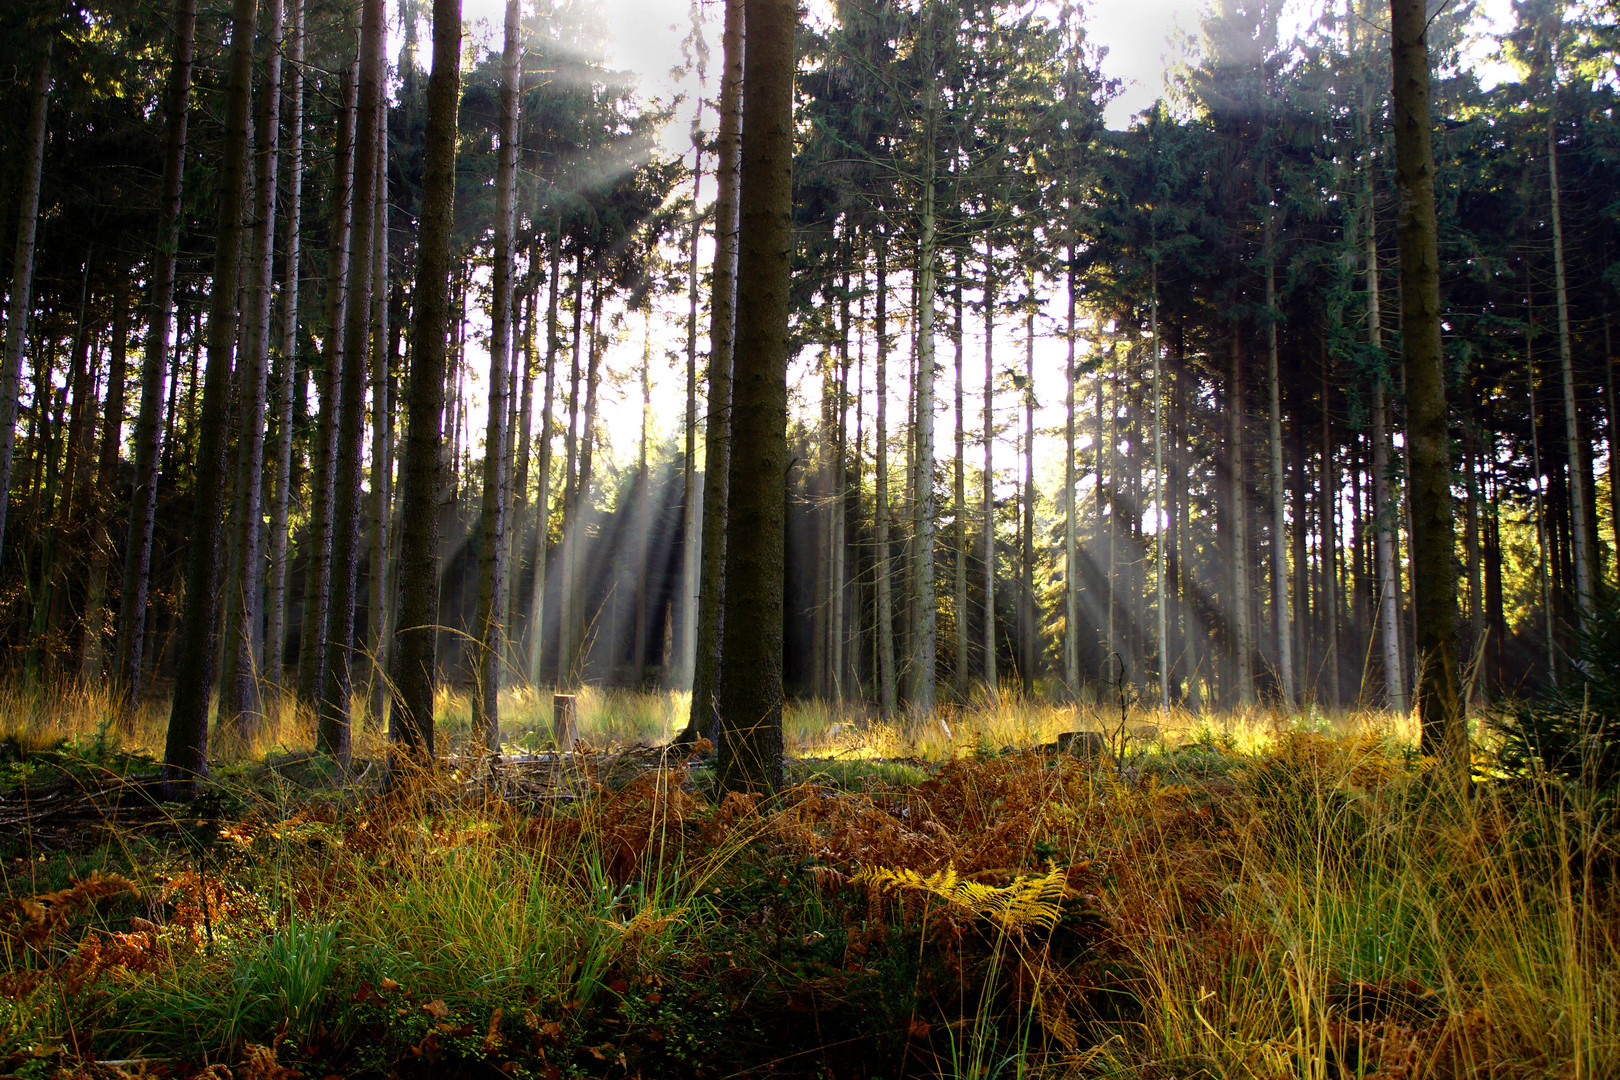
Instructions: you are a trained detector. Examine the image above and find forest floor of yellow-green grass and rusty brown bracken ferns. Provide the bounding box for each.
[0,693,1620,1080]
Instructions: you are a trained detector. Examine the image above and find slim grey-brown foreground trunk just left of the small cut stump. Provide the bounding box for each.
[473,0,518,753]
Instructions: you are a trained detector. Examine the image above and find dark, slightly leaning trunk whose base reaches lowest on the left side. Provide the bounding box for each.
[164,0,258,798]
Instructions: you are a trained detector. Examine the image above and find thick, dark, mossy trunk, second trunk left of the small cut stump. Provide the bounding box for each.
[389,0,462,761]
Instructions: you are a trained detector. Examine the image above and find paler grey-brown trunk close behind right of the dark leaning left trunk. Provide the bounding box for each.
[219,0,282,746]
